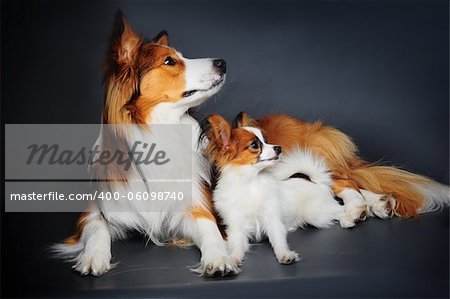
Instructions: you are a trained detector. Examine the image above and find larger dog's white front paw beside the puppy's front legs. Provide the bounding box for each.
[193,254,240,277]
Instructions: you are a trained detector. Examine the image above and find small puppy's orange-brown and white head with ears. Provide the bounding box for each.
[201,114,281,172]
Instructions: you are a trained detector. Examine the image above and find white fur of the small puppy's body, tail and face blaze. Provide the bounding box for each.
[214,136,344,263]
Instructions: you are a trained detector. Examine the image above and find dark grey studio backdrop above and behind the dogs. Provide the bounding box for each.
[2,0,449,181]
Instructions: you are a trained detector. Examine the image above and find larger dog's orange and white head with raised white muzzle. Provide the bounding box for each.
[103,11,226,124]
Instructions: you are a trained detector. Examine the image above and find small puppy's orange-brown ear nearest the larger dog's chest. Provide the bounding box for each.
[203,114,231,150]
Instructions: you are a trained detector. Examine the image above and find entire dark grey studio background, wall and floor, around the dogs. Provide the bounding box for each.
[1,0,449,297]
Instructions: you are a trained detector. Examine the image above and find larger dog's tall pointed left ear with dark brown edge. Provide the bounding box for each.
[109,10,142,65]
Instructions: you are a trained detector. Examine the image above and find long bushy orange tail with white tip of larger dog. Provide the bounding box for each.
[351,166,450,217]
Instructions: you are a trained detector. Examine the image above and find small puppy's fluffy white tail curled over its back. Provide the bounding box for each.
[273,149,332,186]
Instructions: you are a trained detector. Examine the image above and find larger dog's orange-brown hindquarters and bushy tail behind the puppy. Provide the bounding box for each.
[235,112,450,227]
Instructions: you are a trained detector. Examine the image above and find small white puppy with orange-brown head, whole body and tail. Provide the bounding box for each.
[202,115,344,264]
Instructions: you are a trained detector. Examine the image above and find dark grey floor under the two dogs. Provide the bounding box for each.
[4,210,449,298]
